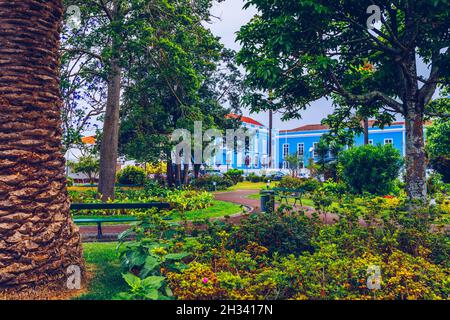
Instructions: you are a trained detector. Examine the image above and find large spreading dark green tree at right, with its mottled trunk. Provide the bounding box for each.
[238,0,450,201]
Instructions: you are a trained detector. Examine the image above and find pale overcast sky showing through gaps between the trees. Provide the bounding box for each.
[207,0,429,129]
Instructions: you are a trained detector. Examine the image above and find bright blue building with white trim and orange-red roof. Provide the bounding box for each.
[213,117,406,171]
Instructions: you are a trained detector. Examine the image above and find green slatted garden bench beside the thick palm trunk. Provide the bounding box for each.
[70,202,170,240]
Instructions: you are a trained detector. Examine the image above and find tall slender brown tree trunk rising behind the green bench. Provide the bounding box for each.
[98,61,122,201]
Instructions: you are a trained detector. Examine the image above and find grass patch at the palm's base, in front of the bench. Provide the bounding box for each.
[76,242,128,300]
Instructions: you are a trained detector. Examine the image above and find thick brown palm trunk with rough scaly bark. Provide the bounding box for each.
[0,0,83,292]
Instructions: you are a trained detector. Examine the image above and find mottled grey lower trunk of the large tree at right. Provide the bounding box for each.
[405,111,427,203]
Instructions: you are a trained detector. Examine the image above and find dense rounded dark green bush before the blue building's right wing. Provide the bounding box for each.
[339,145,402,195]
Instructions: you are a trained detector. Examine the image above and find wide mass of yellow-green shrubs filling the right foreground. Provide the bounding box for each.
[167,198,450,300]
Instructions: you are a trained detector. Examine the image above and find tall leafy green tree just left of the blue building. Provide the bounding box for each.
[120,9,242,185]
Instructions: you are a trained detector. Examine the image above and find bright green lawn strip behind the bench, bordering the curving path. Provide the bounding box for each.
[74,200,242,225]
